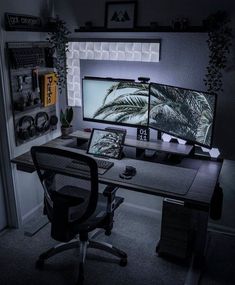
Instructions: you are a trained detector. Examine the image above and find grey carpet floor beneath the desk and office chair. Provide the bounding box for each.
[0,205,235,285]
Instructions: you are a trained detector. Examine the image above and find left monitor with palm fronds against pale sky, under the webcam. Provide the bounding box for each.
[82,77,149,126]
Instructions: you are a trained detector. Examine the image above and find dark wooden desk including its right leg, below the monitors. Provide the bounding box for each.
[12,133,222,284]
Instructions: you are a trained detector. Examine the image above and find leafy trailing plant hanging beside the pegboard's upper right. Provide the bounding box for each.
[47,15,70,92]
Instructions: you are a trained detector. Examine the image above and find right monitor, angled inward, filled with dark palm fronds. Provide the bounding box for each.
[149,83,216,148]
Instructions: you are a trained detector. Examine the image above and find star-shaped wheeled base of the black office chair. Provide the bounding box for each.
[36,235,127,285]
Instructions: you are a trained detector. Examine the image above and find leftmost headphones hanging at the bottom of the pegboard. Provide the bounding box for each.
[17,116,36,140]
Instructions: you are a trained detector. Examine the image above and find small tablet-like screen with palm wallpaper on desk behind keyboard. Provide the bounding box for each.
[87,129,126,158]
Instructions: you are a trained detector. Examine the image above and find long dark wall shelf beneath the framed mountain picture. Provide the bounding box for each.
[74,26,207,33]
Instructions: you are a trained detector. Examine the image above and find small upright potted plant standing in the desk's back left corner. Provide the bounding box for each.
[60,107,73,138]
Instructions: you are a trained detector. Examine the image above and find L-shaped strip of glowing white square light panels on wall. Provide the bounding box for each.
[67,40,160,106]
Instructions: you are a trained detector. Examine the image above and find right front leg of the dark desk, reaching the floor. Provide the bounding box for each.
[184,211,209,285]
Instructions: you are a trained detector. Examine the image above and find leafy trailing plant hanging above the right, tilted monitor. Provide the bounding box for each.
[204,11,232,93]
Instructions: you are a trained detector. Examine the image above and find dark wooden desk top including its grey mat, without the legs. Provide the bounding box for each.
[12,134,222,211]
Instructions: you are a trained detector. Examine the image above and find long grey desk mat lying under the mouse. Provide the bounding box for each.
[103,158,197,195]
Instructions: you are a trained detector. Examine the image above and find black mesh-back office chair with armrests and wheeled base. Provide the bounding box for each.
[31,146,127,285]
